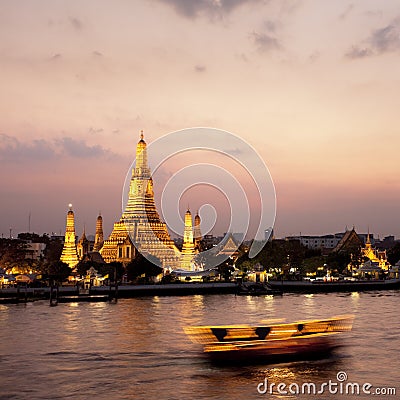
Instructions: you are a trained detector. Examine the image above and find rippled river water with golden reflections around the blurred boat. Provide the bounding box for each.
[0,291,400,400]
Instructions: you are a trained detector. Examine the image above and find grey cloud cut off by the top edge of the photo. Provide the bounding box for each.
[158,0,260,18]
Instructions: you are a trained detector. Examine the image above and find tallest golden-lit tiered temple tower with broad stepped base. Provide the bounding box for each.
[100,132,181,269]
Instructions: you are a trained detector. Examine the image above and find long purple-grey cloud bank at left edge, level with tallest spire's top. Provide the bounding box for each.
[0,134,114,162]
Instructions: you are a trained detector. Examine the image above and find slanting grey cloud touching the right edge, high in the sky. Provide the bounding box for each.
[345,17,400,59]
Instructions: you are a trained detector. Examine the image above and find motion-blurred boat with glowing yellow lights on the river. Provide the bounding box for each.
[184,315,354,363]
